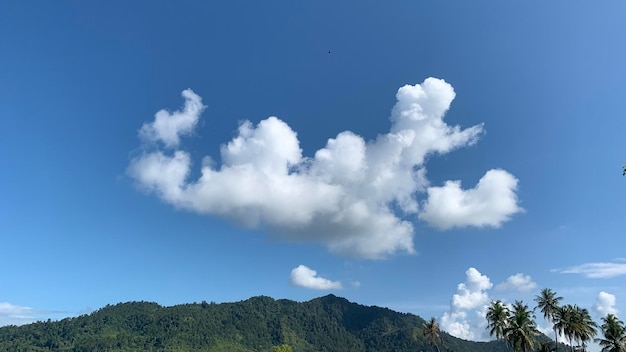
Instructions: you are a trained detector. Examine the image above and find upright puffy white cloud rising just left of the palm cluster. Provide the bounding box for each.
[441,268,493,340]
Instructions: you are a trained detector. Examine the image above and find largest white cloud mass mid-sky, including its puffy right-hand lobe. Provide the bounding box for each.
[127,78,522,259]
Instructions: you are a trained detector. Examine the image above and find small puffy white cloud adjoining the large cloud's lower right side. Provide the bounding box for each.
[419,169,522,230]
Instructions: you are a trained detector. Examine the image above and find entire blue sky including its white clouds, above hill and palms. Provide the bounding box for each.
[0,1,626,348]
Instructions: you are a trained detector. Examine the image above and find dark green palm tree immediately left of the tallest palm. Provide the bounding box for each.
[504,301,539,352]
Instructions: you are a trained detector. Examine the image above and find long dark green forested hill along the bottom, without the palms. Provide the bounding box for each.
[0,295,505,352]
